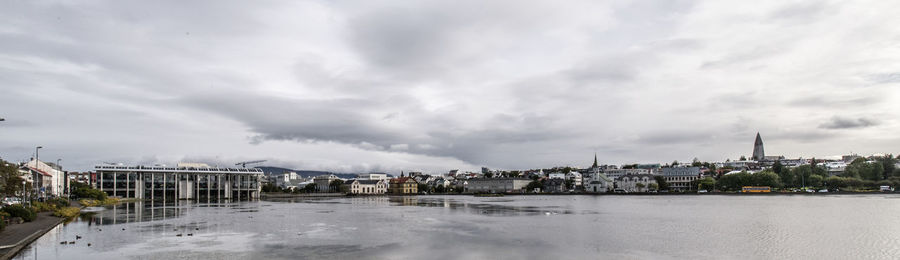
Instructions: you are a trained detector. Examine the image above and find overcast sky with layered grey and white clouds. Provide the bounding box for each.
[0,0,900,173]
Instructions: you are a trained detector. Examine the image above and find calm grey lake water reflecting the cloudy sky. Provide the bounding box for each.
[15,195,900,259]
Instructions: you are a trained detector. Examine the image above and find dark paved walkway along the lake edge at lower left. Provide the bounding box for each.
[0,209,65,260]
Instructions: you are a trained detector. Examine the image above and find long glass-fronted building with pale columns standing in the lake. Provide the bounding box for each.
[95,164,263,200]
